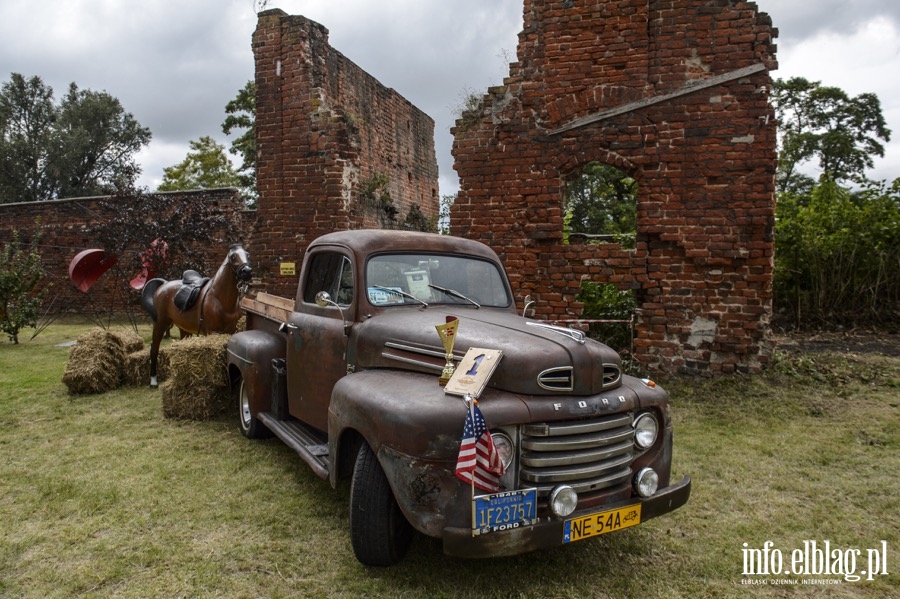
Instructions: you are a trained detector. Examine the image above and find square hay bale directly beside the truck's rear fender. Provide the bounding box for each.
[161,335,230,420]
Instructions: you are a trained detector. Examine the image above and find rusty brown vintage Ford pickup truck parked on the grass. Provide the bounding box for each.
[228,230,691,565]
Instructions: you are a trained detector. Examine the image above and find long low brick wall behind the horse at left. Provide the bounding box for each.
[0,189,246,315]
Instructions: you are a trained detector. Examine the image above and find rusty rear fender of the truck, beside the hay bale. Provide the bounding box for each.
[227,330,285,415]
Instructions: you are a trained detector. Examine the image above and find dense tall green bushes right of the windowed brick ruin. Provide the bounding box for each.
[775,179,900,326]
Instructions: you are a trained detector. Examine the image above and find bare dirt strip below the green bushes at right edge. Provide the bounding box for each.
[774,329,900,357]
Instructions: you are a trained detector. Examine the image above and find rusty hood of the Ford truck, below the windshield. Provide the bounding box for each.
[347,306,622,396]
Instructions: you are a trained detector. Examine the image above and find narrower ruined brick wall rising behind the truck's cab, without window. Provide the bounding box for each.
[252,9,438,297]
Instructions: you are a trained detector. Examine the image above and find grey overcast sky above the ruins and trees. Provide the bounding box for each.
[0,0,900,195]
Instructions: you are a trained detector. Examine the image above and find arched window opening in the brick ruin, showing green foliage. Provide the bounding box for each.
[563,162,638,248]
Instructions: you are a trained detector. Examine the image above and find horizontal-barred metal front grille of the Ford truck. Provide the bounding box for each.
[519,414,634,497]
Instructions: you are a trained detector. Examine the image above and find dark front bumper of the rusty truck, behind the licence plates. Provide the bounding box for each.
[443,476,691,558]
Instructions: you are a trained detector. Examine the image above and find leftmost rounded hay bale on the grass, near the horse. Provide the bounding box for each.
[62,329,125,395]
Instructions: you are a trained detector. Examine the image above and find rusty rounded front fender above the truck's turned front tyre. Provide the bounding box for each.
[328,369,529,536]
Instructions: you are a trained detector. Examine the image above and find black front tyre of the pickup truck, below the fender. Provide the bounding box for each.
[350,442,412,566]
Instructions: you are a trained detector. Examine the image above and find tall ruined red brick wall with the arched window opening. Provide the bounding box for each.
[451,0,777,374]
